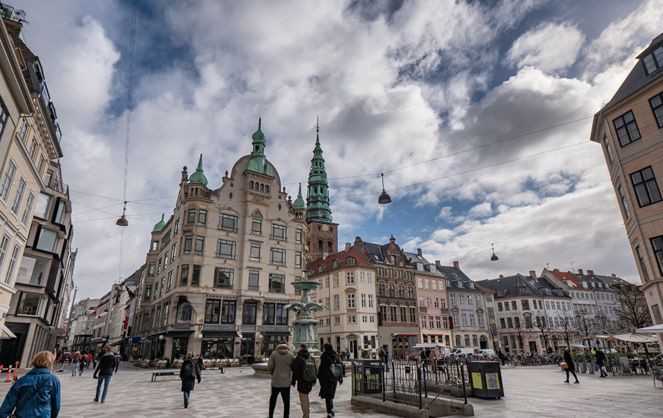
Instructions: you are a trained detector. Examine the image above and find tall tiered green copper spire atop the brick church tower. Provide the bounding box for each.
[306,122,332,223]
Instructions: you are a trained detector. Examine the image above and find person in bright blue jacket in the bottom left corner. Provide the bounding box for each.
[0,351,60,418]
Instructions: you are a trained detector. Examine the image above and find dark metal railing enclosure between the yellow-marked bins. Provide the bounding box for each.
[352,360,469,409]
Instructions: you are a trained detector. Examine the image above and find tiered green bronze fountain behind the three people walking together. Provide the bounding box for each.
[251,280,322,375]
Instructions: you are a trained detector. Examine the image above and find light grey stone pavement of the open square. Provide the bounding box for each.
[0,363,663,418]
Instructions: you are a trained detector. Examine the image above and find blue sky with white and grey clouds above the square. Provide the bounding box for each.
[14,0,663,298]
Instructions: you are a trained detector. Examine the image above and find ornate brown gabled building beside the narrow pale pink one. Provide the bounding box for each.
[354,236,419,359]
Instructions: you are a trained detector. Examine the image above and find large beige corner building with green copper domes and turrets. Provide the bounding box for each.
[134,122,306,359]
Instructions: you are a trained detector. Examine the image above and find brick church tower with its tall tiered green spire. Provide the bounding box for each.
[306,122,338,261]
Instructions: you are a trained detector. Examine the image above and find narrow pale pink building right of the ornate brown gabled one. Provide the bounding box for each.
[403,249,452,347]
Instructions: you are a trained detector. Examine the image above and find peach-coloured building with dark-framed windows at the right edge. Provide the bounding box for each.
[590,33,663,343]
